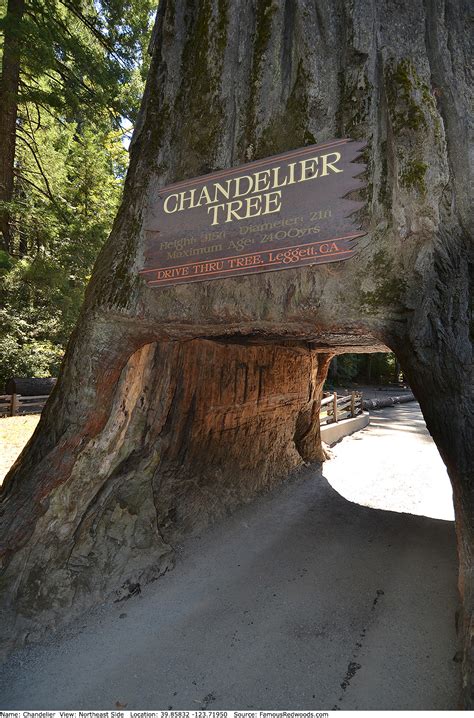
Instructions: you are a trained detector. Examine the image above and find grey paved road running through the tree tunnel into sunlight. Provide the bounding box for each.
[0,404,459,710]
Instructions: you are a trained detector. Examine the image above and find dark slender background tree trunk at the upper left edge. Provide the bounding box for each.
[0,0,25,252]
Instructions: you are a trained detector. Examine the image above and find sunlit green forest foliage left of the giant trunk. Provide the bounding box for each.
[0,0,156,393]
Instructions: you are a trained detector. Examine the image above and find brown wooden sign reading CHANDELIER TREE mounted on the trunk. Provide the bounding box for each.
[140,139,365,287]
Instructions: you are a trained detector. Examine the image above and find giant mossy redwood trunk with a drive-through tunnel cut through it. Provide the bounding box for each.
[1,0,474,705]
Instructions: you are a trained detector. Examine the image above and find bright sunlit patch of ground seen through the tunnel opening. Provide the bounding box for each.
[324,402,454,521]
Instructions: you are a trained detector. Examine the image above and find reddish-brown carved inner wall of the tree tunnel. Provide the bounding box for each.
[155,340,326,536]
